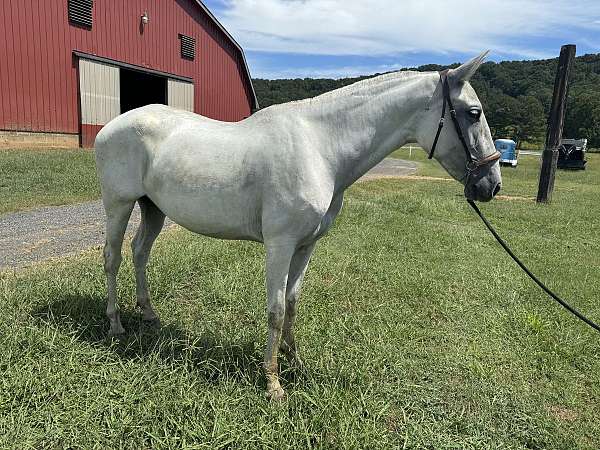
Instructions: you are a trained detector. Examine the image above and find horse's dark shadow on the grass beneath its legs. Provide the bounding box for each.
[31,294,306,388]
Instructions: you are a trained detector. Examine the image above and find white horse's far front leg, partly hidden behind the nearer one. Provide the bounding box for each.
[280,242,316,366]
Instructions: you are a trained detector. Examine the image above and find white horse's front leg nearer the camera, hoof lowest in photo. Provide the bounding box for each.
[264,242,295,400]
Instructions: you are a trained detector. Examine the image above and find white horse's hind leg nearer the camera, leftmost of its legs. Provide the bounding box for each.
[104,201,135,336]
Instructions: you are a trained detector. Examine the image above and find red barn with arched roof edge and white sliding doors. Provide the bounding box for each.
[0,0,258,147]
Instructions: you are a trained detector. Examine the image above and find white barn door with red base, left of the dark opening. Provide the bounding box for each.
[79,58,121,147]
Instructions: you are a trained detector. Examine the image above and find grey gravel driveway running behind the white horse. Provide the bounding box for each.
[0,158,417,270]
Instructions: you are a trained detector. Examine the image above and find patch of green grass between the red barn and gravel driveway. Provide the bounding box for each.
[0,149,100,214]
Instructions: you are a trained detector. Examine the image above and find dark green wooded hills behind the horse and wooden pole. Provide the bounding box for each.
[253,54,600,148]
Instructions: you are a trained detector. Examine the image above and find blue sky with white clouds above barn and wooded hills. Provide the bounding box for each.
[204,0,600,79]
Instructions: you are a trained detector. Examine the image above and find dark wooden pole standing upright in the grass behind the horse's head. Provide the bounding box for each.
[537,45,575,203]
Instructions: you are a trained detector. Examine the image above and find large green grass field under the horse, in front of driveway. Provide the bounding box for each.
[0,150,600,449]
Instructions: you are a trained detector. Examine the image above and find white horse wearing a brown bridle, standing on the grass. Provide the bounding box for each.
[96,54,501,399]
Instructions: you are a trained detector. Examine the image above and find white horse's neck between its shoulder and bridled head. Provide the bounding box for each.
[304,72,437,192]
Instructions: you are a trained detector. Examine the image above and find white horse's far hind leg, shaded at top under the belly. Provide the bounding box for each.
[131,197,165,325]
